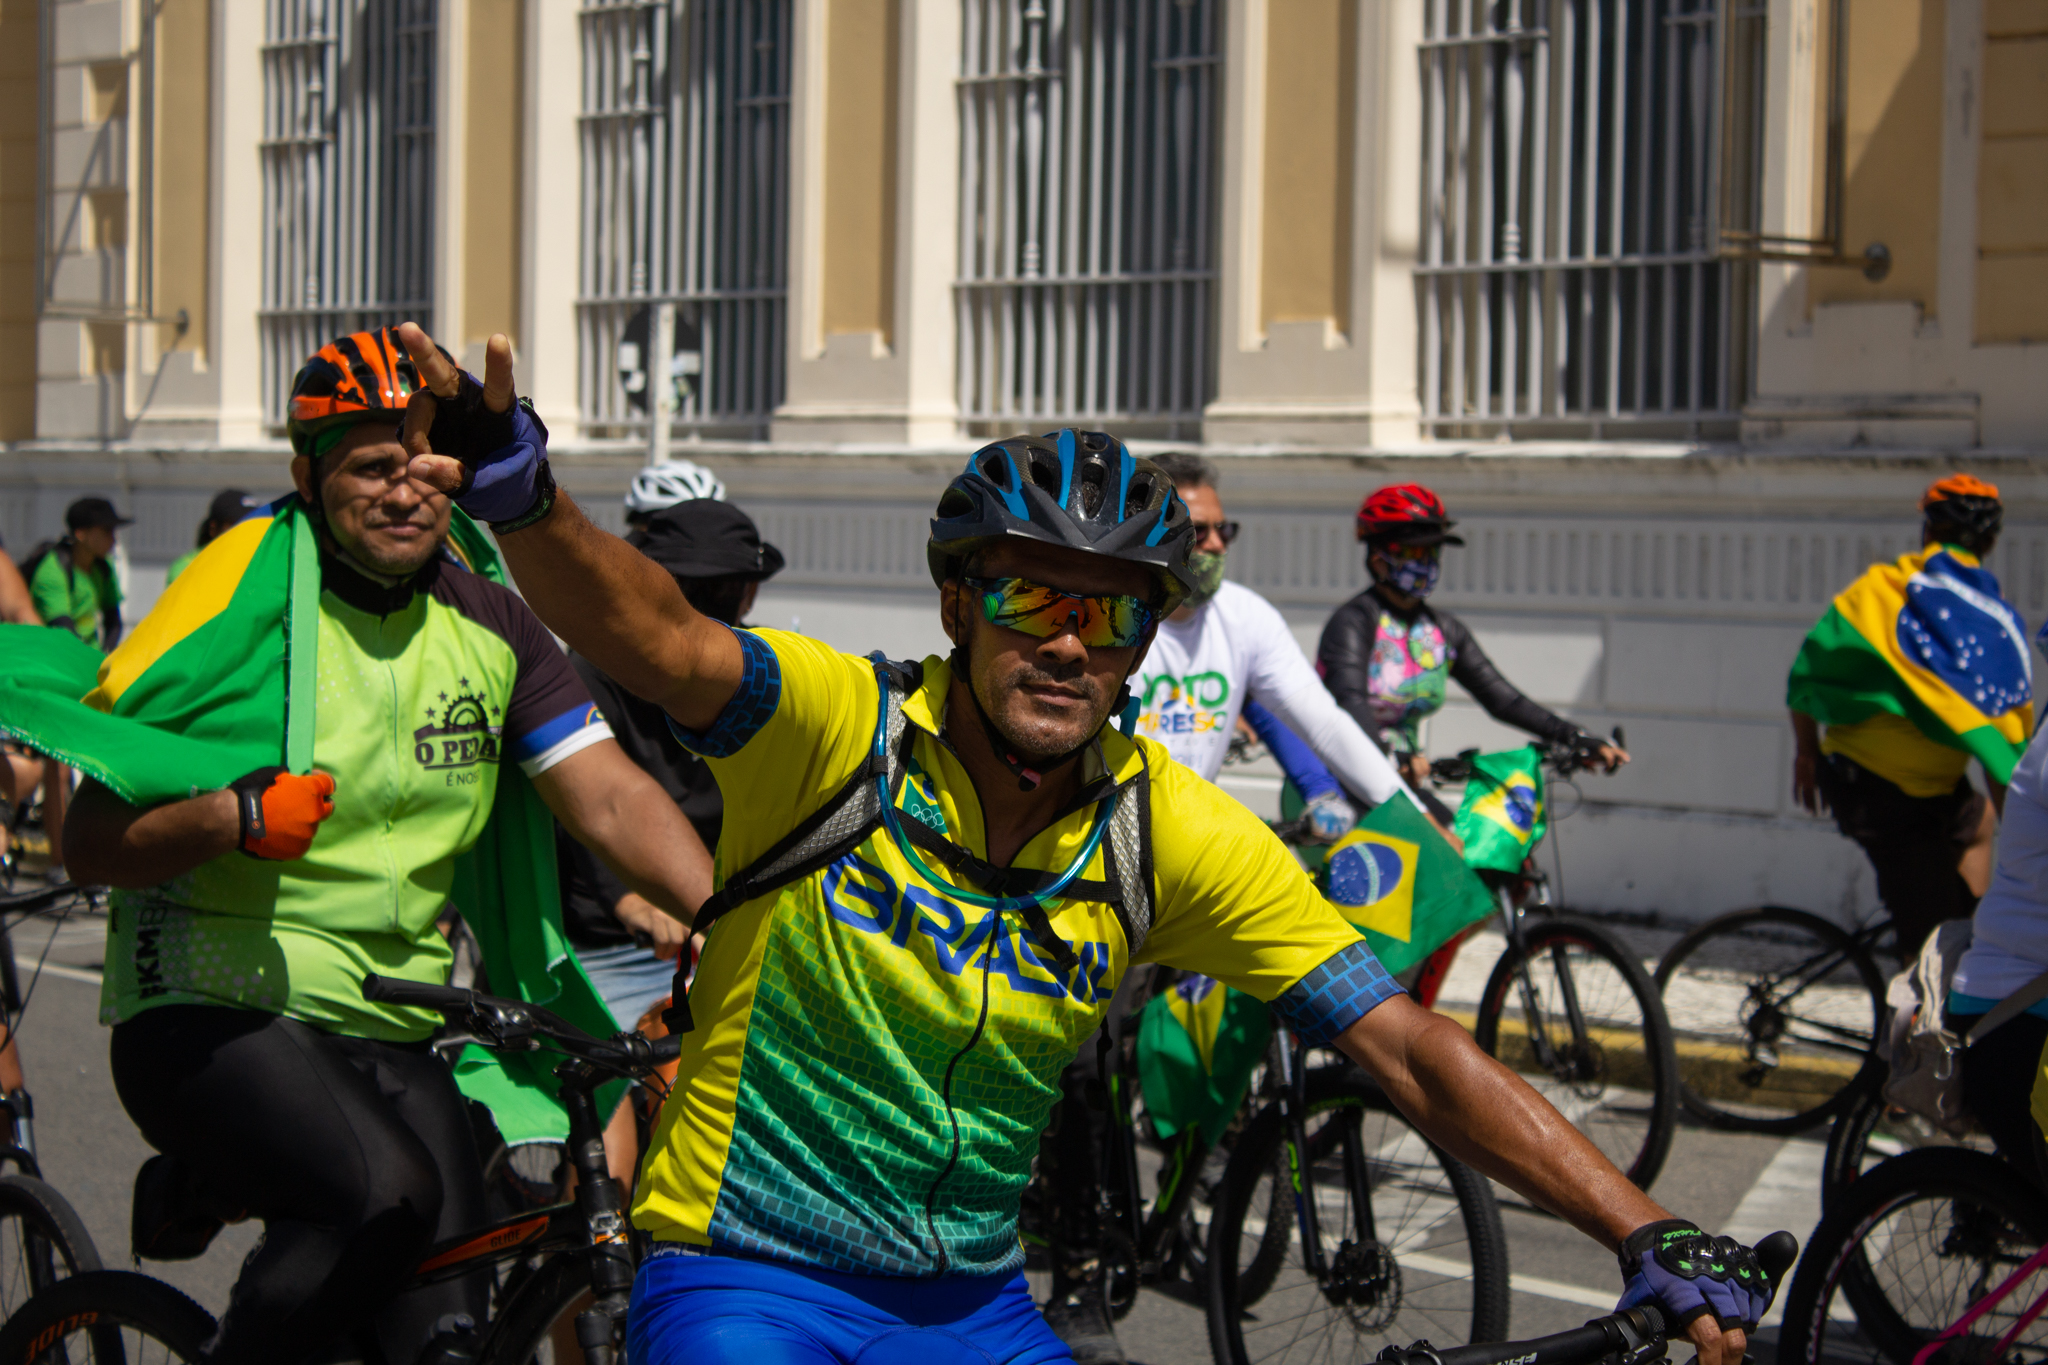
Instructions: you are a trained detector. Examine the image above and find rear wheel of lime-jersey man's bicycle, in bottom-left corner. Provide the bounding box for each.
[0,1271,213,1365]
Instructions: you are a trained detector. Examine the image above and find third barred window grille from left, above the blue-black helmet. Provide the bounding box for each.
[954,0,1223,436]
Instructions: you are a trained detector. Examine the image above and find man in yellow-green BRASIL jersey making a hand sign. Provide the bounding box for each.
[401,323,1772,1365]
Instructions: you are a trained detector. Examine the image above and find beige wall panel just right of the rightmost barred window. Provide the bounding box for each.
[1810,0,1946,317]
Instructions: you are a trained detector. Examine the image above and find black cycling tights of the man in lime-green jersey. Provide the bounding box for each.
[113,1005,489,1365]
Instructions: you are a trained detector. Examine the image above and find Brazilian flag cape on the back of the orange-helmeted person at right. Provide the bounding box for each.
[1786,544,2034,782]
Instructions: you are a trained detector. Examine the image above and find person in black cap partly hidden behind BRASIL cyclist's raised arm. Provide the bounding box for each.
[555,497,782,1181]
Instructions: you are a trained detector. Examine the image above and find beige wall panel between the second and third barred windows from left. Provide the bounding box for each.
[819,0,899,346]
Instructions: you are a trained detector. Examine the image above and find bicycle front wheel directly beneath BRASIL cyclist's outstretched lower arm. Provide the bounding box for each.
[1208,1066,1507,1365]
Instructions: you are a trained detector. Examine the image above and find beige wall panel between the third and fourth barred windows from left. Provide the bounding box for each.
[1260,0,1358,332]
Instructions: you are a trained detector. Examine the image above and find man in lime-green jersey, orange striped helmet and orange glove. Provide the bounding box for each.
[66,332,711,1365]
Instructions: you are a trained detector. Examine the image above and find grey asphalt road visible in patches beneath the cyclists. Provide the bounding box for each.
[0,900,1825,1365]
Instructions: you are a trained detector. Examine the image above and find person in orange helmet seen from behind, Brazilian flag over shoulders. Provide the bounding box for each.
[1788,475,2032,960]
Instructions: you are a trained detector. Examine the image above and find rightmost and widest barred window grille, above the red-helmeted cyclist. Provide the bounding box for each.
[1415,0,1763,438]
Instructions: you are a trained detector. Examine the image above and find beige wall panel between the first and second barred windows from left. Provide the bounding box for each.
[468,0,524,354]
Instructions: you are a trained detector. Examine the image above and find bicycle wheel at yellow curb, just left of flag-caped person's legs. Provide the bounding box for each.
[1657,905,1884,1134]
